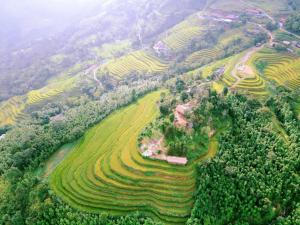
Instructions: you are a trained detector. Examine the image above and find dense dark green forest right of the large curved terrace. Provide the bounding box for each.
[187,90,300,225]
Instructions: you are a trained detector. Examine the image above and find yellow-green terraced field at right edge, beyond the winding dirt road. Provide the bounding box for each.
[254,50,300,90]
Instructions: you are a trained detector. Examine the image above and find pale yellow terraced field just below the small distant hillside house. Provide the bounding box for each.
[101,51,168,78]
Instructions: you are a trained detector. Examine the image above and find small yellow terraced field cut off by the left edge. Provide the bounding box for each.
[0,97,25,126]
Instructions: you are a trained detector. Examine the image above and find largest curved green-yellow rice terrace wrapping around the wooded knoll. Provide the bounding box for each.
[51,91,217,224]
